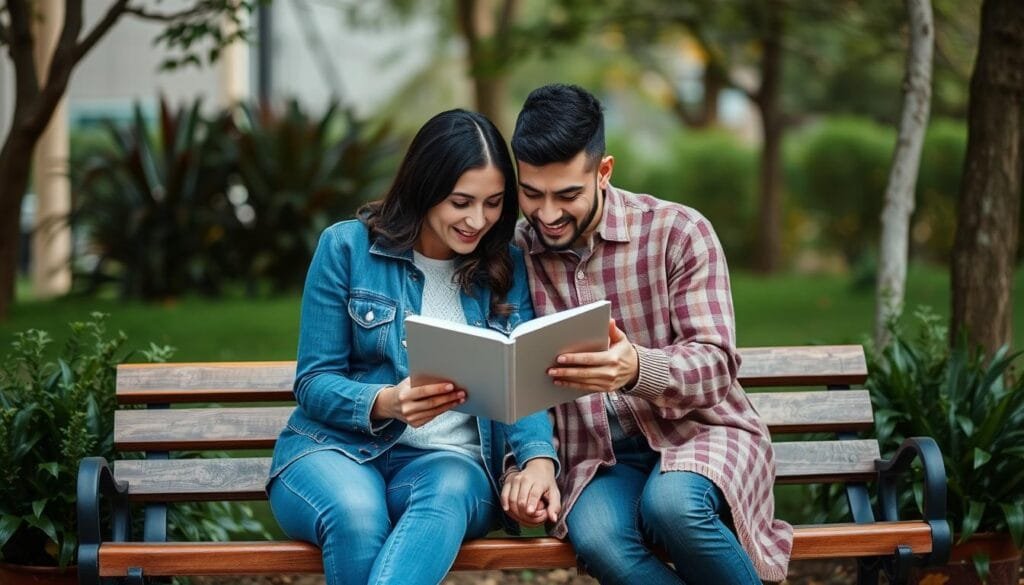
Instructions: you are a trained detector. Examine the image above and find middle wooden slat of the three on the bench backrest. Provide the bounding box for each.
[114,390,872,451]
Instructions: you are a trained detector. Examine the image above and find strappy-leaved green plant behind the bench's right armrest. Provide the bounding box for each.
[867,310,1024,568]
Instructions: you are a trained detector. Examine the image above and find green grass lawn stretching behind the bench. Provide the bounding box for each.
[0,265,1024,361]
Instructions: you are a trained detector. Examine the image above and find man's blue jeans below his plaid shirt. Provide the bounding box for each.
[566,436,761,585]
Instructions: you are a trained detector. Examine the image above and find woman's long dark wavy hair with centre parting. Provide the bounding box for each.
[356,110,519,315]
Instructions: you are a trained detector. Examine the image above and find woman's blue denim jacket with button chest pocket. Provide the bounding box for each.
[269,219,558,522]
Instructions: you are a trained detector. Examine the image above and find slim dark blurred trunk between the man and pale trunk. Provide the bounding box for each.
[755,5,783,274]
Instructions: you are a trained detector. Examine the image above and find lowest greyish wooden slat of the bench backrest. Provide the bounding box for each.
[114,440,879,501]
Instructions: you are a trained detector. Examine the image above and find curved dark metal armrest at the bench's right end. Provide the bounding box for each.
[874,436,952,565]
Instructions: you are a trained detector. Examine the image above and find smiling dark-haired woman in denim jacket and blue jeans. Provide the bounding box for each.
[268,110,558,585]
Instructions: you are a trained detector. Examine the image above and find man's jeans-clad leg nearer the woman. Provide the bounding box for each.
[566,437,684,585]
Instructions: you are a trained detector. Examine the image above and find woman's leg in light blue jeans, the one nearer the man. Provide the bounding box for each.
[370,446,498,585]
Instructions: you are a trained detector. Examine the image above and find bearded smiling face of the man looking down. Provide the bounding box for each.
[519,151,614,251]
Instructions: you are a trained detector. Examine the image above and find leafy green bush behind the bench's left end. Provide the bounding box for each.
[0,314,266,567]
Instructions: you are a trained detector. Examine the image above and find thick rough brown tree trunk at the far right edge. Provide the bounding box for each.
[950,0,1024,356]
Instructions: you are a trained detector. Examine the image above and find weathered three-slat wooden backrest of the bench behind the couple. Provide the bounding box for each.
[108,345,879,502]
